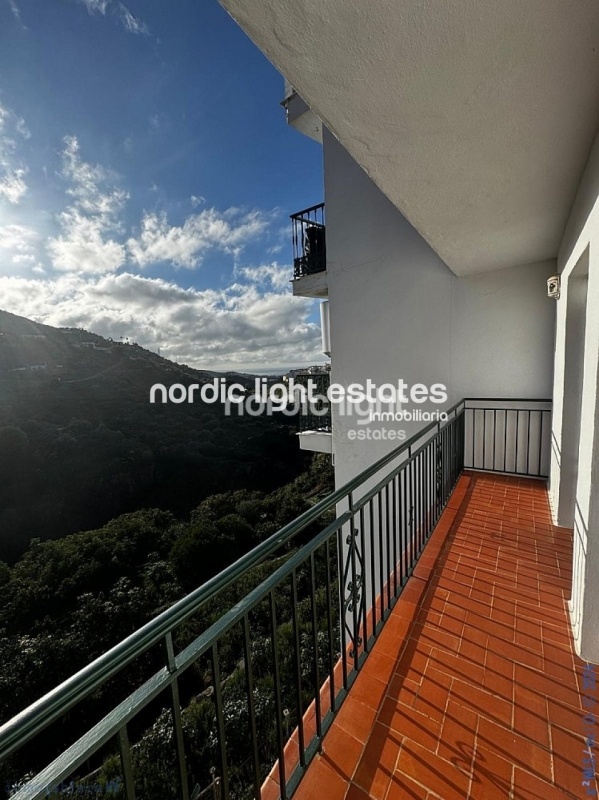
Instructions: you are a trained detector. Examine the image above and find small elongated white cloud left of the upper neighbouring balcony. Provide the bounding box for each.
[127,208,268,268]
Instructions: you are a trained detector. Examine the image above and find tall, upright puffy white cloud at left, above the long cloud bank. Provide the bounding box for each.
[47,136,128,274]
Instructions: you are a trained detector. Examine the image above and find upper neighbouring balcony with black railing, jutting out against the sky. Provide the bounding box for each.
[291,203,328,298]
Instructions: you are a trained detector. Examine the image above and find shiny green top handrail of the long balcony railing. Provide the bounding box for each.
[0,399,465,761]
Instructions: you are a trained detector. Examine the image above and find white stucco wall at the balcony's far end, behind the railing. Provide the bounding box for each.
[323,130,556,485]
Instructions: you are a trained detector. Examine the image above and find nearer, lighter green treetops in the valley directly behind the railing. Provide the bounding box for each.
[0,456,338,800]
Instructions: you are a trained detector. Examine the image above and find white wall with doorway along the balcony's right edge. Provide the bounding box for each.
[550,134,599,663]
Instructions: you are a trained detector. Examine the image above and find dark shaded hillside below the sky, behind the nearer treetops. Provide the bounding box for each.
[0,311,308,562]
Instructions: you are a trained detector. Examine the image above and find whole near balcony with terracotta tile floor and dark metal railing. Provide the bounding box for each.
[0,400,596,800]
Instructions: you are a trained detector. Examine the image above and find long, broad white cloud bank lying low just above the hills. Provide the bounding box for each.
[0,265,322,370]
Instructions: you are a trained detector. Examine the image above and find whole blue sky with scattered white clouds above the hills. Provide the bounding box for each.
[0,0,323,370]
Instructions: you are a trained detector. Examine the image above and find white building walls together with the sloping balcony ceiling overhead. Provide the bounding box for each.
[223,0,599,662]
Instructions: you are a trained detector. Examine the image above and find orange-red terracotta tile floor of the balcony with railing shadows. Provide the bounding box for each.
[294,474,599,800]
